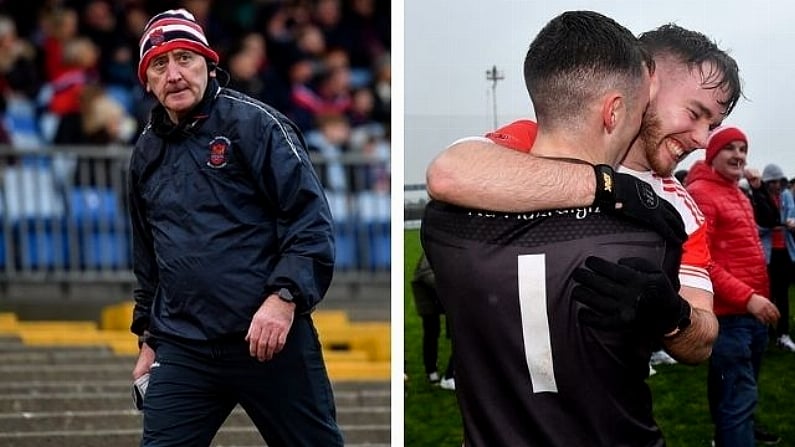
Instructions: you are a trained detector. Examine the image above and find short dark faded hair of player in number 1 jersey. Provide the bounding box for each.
[524,11,653,130]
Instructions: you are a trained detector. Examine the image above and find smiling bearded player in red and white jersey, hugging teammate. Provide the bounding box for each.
[428,25,741,363]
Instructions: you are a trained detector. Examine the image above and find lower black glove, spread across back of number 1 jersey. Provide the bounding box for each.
[572,256,690,337]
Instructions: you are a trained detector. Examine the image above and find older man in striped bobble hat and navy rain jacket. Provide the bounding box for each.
[130,9,343,447]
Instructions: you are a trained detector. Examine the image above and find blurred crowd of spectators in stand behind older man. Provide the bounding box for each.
[0,0,391,193]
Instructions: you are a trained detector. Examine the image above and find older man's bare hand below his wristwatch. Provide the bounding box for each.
[246,293,295,362]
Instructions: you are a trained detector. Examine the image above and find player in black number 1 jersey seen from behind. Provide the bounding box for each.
[421,11,690,447]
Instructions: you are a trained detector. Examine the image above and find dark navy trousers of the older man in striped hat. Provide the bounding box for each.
[141,316,343,447]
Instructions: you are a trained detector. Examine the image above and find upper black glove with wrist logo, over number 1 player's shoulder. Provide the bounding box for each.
[593,165,687,245]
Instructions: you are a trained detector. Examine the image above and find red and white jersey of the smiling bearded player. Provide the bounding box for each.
[478,120,712,293]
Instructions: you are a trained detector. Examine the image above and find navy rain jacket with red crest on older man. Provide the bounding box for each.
[129,80,334,340]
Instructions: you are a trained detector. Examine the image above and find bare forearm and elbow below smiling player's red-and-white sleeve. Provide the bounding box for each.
[663,286,718,365]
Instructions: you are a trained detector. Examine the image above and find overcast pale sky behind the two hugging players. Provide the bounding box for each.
[404,0,795,184]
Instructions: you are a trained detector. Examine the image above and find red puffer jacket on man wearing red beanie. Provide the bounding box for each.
[687,161,770,316]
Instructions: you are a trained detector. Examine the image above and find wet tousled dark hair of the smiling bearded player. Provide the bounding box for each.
[639,23,743,116]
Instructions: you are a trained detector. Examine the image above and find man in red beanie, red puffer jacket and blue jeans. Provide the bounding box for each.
[687,126,779,447]
